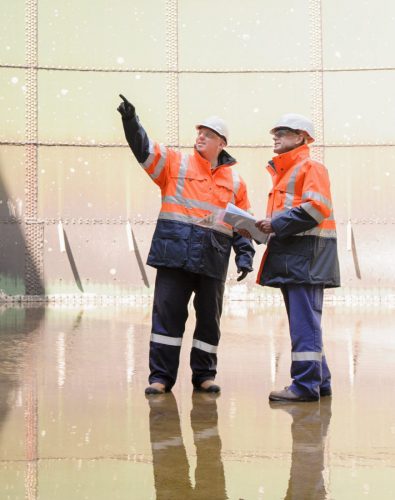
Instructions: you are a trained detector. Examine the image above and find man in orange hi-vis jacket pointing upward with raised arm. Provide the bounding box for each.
[118,96,254,394]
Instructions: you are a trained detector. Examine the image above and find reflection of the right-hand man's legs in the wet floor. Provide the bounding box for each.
[270,398,332,500]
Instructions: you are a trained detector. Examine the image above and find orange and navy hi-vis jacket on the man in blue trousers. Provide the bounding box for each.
[257,145,340,287]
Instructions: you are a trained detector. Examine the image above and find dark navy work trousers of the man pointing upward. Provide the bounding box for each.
[149,268,225,389]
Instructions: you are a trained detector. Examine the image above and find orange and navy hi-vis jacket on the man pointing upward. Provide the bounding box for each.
[123,117,255,281]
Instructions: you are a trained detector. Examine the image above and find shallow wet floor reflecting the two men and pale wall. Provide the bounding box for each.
[0,303,395,500]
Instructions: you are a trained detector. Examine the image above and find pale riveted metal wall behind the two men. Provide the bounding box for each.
[0,0,395,298]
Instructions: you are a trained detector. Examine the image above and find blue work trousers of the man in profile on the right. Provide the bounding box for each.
[281,285,331,399]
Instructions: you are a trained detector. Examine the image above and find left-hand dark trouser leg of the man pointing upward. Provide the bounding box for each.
[149,268,195,389]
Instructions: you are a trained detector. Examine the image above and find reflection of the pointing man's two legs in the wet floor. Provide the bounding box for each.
[148,393,228,500]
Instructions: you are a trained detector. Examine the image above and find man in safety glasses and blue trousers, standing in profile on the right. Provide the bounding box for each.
[256,114,340,402]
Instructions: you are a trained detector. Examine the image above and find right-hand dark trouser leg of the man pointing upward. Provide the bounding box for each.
[190,275,225,387]
